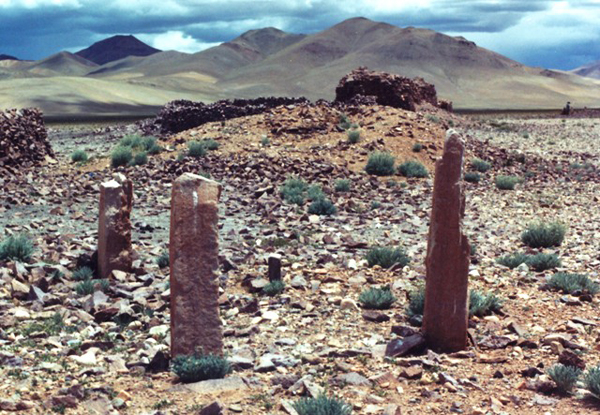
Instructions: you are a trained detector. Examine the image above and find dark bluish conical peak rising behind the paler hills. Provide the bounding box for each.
[76,35,160,65]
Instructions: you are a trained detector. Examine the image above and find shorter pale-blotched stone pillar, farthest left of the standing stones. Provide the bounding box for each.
[98,174,133,278]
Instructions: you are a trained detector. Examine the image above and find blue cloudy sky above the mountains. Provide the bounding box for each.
[0,0,600,70]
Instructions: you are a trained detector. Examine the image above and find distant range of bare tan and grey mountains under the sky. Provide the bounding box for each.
[0,18,600,114]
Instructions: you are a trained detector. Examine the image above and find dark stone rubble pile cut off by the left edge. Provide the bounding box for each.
[0,108,54,169]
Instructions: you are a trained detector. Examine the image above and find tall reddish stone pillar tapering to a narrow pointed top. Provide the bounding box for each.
[423,130,471,352]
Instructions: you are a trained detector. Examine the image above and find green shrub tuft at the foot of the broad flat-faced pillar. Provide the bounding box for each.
[171,355,231,383]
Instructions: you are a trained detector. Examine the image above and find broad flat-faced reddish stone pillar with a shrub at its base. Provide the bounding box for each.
[169,173,223,357]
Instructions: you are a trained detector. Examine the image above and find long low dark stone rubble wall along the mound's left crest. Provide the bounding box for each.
[141,97,308,134]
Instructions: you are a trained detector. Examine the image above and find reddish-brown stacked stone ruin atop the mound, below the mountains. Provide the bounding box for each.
[335,67,452,111]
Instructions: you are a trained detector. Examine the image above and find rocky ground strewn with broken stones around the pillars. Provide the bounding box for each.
[0,105,600,415]
